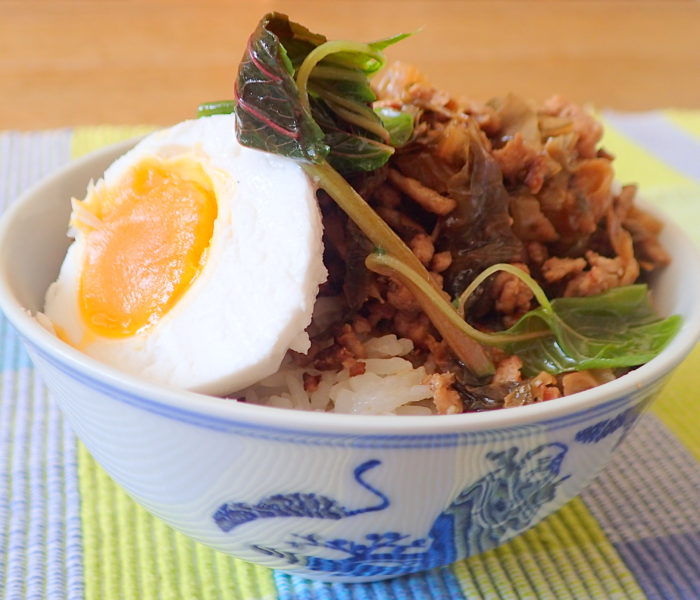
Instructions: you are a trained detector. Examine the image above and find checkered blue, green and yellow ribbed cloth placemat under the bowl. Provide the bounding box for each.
[0,111,700,600]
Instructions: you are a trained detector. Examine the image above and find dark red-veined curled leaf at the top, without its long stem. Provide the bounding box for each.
[236,13,412,174]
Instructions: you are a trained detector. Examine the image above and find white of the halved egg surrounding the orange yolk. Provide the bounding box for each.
[45,115,326,395]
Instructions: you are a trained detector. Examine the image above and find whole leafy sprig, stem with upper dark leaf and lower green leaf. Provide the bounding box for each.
[204,13,680,377]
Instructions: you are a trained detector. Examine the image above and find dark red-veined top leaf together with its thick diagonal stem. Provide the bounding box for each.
[228,13,494,377]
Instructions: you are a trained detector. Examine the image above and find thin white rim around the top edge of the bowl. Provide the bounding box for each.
[0,138,700,437]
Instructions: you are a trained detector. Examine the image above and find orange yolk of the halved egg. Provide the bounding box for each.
[73,158,217,338]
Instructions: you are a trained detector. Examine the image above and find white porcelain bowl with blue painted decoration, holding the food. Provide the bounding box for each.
[0,142,700,581]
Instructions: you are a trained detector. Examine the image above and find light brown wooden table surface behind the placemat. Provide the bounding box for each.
[0,0,700,129]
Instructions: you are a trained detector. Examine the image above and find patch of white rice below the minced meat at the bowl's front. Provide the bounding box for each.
[243,334,433,415]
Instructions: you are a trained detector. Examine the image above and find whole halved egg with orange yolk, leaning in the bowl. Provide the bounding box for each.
[44,115,326,395]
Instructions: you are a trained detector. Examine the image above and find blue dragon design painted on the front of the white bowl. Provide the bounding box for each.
[213,442,569,577]
